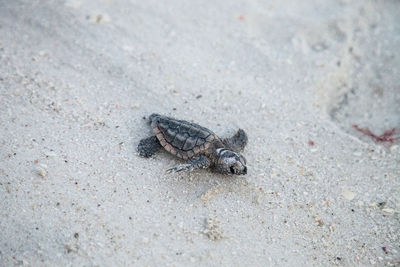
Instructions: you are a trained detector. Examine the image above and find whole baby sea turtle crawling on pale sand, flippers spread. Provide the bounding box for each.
[138,114,247,175]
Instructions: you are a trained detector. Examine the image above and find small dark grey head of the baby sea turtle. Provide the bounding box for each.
[215,148,247,175]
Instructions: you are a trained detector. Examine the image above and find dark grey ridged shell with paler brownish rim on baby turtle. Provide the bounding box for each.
[150,114,219,159]
